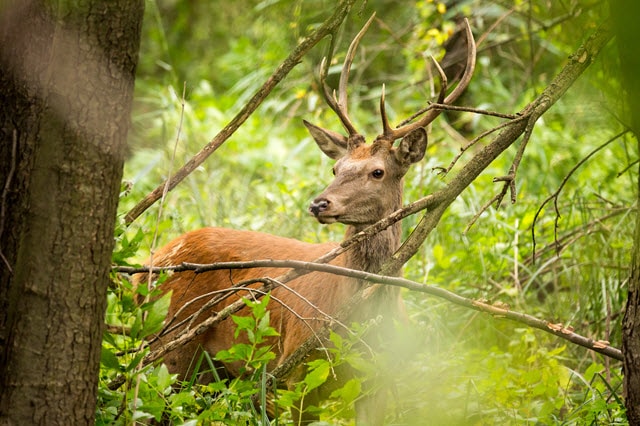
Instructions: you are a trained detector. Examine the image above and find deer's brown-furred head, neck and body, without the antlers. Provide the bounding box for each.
[138,122,427,425]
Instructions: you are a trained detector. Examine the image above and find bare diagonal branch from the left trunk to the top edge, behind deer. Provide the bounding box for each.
[124,0,355,225]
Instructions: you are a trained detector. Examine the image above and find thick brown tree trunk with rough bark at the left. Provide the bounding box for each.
[0,0,144,425]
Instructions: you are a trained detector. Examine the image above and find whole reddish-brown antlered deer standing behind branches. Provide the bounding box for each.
[134,16,475,425]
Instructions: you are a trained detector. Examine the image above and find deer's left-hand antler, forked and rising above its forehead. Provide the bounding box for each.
[320,12,376,136]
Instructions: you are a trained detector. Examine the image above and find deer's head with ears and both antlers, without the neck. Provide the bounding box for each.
[304,14,476,228]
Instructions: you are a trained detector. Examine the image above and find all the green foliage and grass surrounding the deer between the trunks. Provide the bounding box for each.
[105,0,638,425]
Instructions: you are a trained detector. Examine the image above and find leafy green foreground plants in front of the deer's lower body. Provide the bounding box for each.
[101,243,370,425]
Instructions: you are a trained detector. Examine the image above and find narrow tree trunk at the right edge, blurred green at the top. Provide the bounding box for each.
[611,0,640,425]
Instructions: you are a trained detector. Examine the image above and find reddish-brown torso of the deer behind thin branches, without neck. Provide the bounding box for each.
[136,228,360,378]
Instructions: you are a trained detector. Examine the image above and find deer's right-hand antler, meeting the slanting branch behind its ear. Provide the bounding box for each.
[381,18,476,141]
